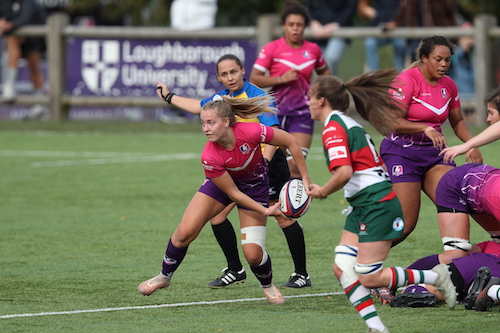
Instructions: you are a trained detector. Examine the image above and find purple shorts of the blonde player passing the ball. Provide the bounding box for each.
[198,177,269,209]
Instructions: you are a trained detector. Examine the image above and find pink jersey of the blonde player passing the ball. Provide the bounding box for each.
[201,122,274,182]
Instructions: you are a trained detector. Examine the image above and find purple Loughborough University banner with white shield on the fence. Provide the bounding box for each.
[66,38,257,99]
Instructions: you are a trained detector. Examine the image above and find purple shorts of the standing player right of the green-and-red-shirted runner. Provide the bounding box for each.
[380,138,456,183]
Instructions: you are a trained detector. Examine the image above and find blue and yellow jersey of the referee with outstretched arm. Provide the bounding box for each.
[200,80,279,126]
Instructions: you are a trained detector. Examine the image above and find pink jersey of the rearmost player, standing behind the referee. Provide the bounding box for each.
[253,37,327,116]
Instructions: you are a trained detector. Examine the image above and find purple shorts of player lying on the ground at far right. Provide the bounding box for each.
[453,252,500,295]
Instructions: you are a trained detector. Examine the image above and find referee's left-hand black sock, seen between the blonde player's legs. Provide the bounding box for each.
[212,219,243,272]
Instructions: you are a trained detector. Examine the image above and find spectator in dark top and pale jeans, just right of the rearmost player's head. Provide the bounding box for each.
[304,0,357,75]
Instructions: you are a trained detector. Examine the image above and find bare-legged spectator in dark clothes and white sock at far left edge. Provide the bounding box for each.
[0,0,45,112]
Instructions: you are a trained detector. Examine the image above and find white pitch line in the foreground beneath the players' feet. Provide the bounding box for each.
[0,292,344,319]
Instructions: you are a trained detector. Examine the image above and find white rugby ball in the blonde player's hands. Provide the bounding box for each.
[280,179,312,218]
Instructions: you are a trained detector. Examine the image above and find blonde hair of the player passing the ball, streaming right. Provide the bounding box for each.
[201,95,277,126]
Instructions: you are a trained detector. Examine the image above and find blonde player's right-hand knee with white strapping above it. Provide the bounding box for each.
[241,226,267,266]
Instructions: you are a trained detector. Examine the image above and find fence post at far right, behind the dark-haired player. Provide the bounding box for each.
[474,14,496,125]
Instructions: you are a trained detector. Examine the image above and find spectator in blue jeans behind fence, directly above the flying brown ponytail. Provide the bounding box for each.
[358,0,406,71]
